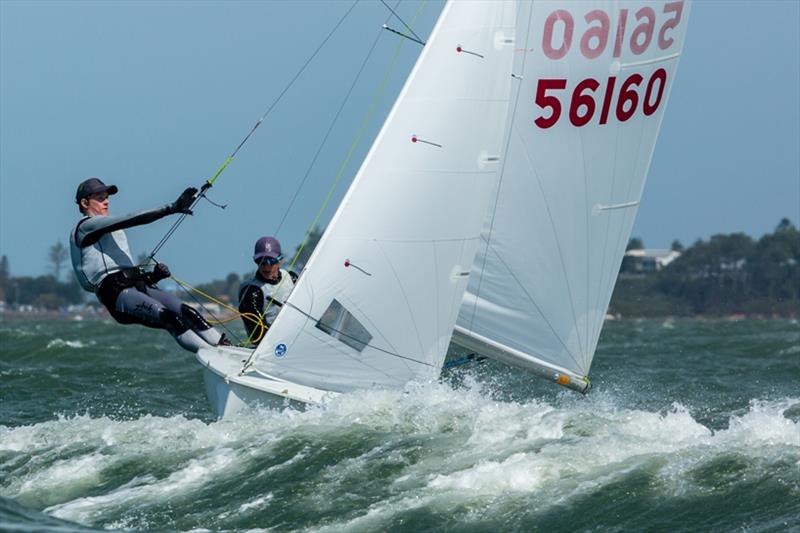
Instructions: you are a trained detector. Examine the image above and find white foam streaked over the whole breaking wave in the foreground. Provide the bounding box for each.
[0,382,800,530]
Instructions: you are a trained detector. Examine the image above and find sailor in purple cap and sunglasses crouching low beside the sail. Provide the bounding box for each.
[239,237,297,343]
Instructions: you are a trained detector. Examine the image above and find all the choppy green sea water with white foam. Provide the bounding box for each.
[0,320,800,532]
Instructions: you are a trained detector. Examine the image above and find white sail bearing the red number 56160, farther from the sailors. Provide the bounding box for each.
[454,0,690,390]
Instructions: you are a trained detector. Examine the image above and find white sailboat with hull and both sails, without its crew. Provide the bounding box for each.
[197,0,690,416]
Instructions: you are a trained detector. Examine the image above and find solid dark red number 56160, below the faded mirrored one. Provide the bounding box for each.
[534,68,667,129]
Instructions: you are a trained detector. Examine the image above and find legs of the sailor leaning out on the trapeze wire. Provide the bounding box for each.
[116,288,211,352]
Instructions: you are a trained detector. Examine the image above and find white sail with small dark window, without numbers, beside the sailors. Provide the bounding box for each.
[247,1,515,391]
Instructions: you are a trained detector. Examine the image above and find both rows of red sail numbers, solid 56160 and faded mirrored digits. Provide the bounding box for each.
[534,0,683,129]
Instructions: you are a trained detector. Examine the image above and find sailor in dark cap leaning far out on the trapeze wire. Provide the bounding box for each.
[70,178,225,352]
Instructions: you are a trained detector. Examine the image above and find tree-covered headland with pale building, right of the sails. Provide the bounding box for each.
[610,218,800,316]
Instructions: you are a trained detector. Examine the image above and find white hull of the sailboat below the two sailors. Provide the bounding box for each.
[197,346,336,418]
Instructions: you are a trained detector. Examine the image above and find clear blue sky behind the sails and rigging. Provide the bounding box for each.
[0,0,800,283]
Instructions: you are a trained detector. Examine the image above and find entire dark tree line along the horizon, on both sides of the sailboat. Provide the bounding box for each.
[0,222,800,317]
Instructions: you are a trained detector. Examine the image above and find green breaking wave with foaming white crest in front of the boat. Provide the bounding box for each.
[0,383,800,531]
